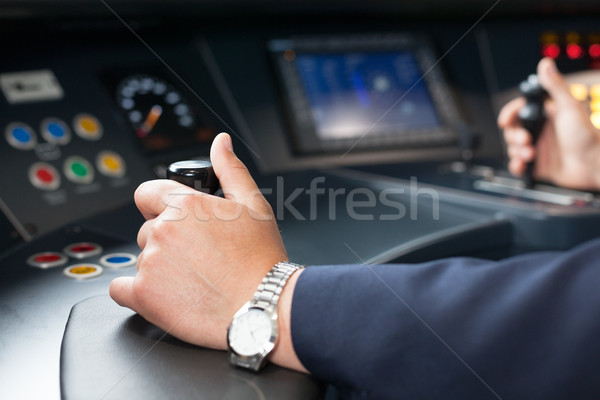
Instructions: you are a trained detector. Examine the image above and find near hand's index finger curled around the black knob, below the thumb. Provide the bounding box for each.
[133,179,199,220]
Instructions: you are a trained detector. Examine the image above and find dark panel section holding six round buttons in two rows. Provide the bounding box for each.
[0,77,152,239]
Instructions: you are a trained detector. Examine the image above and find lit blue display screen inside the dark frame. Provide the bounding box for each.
[295,51,440,140]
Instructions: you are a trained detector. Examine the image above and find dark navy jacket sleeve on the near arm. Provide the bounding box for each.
[291,240,600,399]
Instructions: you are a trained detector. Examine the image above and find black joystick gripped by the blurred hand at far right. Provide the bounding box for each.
[519,75,548,188]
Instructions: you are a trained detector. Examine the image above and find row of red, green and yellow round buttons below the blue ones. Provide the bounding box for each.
[28,150,125,190]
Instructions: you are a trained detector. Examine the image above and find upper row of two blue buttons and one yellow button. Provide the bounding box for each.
[4,114,104,150]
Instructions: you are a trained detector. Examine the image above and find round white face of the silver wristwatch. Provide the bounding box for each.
[229,308,273,356]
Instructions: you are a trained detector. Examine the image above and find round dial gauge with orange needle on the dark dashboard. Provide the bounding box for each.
[116,74,198,150]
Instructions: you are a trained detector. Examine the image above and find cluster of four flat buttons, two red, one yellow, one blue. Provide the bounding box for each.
[27,242,137,279]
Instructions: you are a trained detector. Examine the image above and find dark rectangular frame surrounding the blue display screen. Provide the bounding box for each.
[268,33,461,155]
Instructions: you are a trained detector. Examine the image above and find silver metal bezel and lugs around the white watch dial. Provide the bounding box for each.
[227,301,278,371]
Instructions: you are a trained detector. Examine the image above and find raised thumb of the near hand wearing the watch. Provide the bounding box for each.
[210,133,262,209]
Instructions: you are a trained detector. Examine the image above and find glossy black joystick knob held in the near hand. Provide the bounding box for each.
[167,160,219,194]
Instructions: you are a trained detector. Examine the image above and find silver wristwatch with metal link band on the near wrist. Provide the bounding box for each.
[227,261,304,371]
